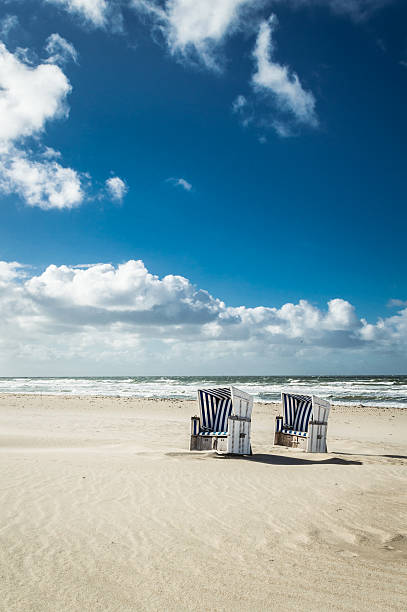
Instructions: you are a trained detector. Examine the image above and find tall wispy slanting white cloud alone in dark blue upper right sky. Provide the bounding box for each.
[252,15,318,128]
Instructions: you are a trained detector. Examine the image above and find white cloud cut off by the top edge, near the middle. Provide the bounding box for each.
[132,0,263,70]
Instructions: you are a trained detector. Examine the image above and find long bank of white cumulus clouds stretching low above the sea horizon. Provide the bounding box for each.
[0,261,407,373]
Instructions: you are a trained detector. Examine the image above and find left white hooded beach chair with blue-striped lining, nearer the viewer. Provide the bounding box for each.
[190,387,253,455]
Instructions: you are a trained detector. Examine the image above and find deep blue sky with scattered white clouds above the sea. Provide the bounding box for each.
[0,0,407,376]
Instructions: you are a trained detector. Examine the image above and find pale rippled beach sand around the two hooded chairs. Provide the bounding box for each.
[0,395,407,612]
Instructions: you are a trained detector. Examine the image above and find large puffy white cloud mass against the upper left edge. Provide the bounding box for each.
[0,41,84,209]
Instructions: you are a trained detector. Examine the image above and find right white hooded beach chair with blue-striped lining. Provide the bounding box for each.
[274,391,331,453]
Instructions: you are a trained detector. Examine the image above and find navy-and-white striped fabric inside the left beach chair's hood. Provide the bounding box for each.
[198,388,232,434]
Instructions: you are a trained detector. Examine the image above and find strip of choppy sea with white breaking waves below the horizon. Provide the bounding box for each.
[0,376,407,408]
